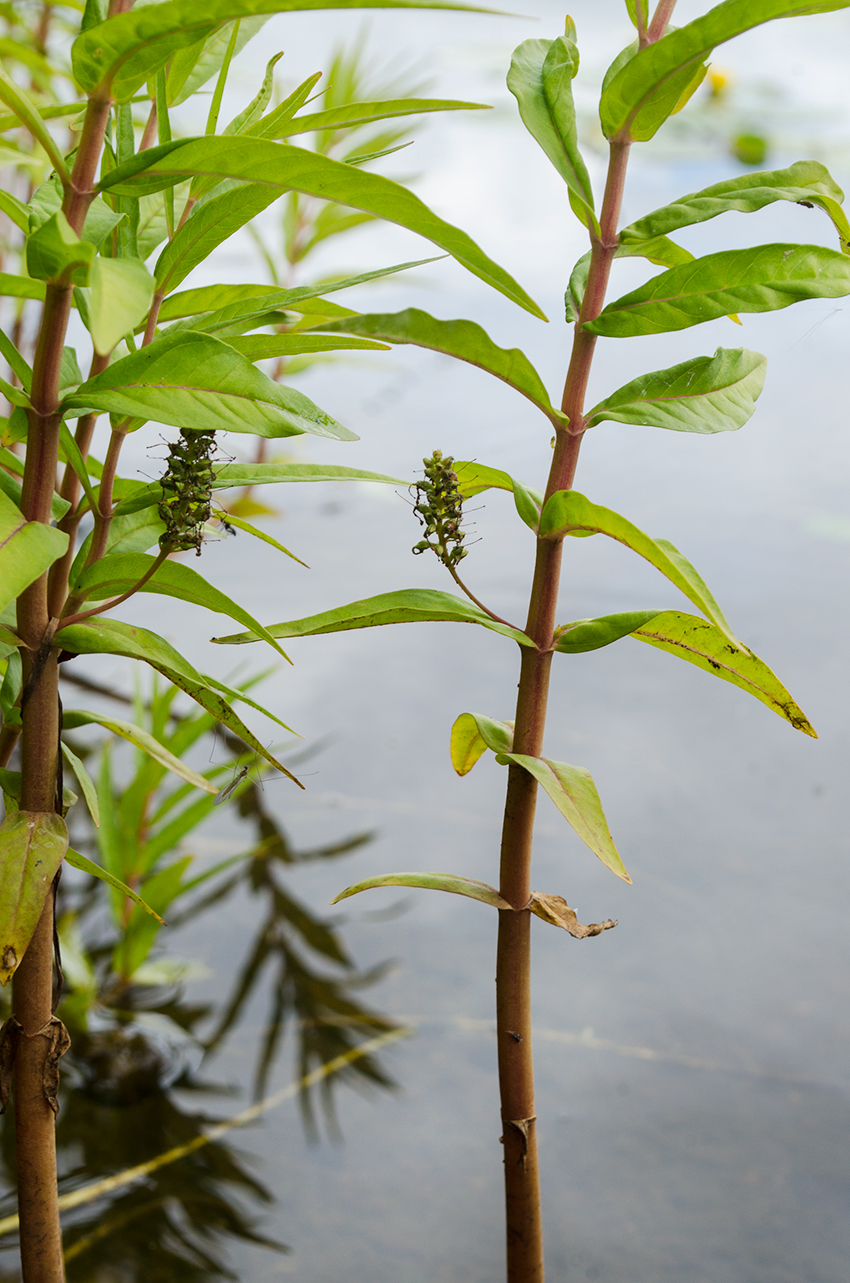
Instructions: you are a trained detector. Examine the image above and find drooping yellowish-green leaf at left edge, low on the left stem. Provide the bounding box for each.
[0,811,68,984]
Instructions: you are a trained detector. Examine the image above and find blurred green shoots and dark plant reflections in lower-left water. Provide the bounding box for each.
[0,681,396,1283]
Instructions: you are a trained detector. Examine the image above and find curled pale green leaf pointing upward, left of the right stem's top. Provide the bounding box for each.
[508,28,599,230]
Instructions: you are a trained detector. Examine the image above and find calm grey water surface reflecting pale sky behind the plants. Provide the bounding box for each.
[1,0,850,1283]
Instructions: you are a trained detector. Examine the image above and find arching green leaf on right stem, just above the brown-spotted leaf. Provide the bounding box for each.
[540,490,745,649]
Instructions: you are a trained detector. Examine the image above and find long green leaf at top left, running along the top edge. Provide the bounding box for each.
[74,0,500,106]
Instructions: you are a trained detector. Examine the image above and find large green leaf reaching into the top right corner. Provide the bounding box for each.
[599,0,846,139]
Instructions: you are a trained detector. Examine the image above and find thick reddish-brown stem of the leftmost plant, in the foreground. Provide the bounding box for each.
[13,87,110,1283]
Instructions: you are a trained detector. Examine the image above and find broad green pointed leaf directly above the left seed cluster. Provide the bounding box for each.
[64,331,356,441]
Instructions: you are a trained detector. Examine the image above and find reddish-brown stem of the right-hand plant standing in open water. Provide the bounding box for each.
[496,135,628,1283]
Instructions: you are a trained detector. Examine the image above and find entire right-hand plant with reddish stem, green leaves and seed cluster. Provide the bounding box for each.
[219,0,850,1283]
